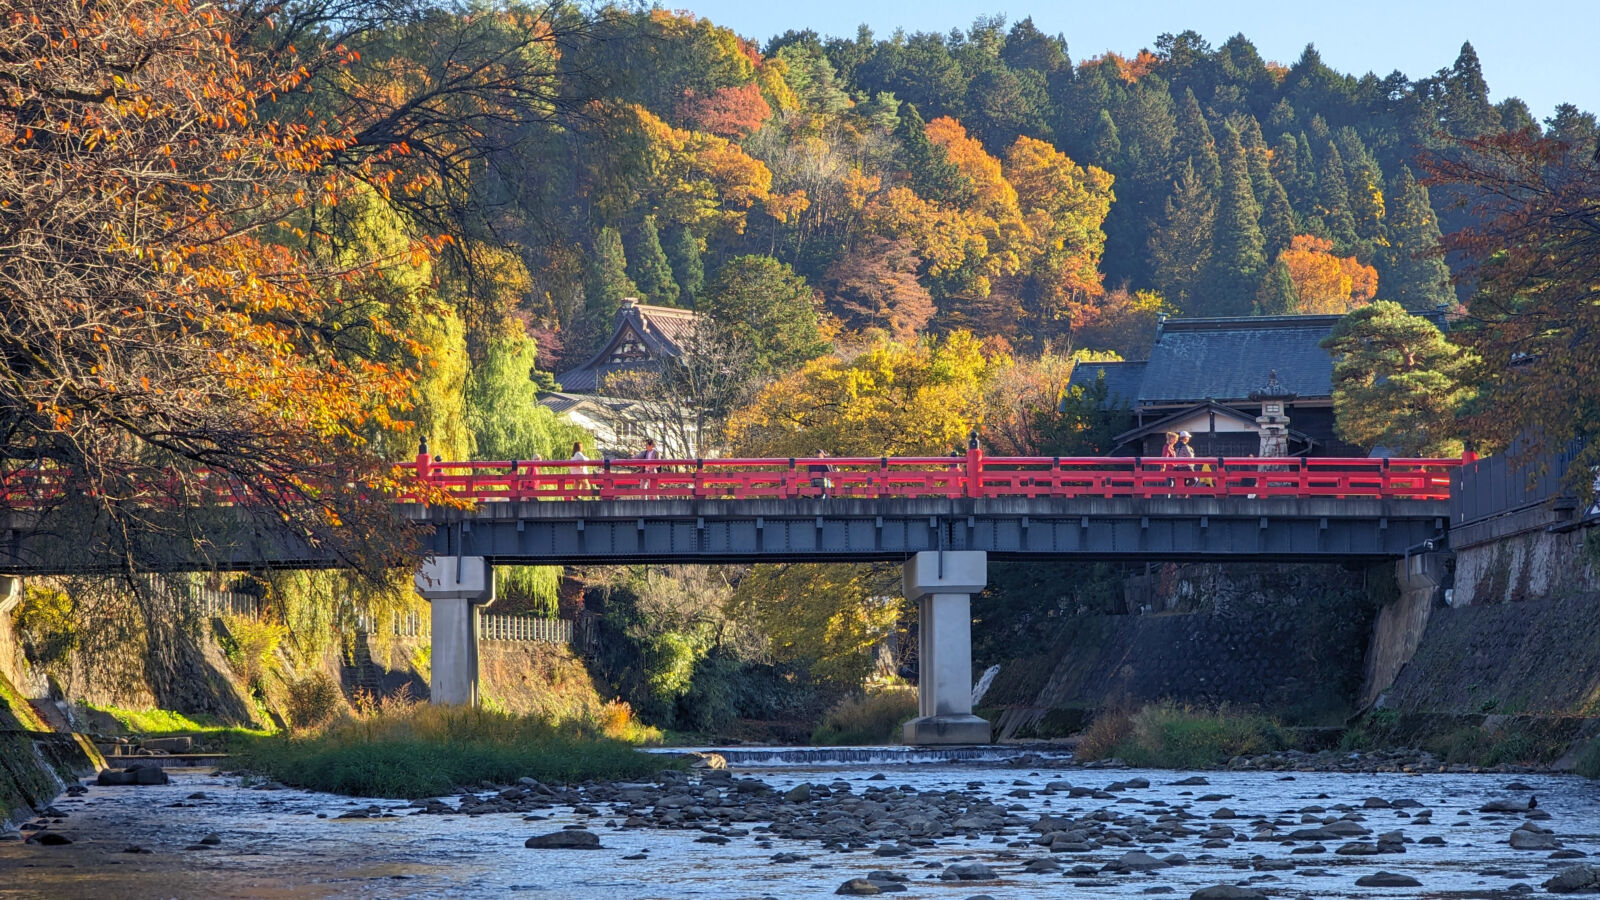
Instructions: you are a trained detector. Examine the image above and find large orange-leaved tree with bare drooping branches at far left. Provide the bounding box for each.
[0,0,429,578]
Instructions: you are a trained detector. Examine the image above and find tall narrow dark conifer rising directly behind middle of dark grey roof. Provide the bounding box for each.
[1202,125,1267,315]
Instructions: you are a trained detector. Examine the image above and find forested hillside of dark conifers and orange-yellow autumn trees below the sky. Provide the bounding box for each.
[476,10,1595,360]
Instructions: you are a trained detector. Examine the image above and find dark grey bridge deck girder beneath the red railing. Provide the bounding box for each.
[406,498,1448,565]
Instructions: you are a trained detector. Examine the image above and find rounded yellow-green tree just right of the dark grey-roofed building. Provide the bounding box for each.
[1322,301,1472,456]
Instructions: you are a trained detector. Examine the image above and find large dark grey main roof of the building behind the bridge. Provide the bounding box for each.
[1139,315,1341,404]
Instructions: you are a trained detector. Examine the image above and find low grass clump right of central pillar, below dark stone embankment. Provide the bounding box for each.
[1074,703,1291,769]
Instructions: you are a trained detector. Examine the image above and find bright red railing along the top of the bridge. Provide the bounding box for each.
[393,450,1461,501]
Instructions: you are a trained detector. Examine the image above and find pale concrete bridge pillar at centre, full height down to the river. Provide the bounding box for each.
[904,551,989,745]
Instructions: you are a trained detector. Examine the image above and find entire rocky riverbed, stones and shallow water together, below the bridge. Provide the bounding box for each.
[0,757,1600,900]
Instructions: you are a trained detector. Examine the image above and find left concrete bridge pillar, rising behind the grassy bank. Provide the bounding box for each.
[416,556,494,706]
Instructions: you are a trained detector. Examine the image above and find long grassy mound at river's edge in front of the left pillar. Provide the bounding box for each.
[237,705,674,799]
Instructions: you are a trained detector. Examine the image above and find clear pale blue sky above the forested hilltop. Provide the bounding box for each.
[662,0,1600,120]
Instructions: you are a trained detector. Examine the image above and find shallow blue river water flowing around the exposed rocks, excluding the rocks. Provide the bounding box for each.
[0,754,1600,900]
